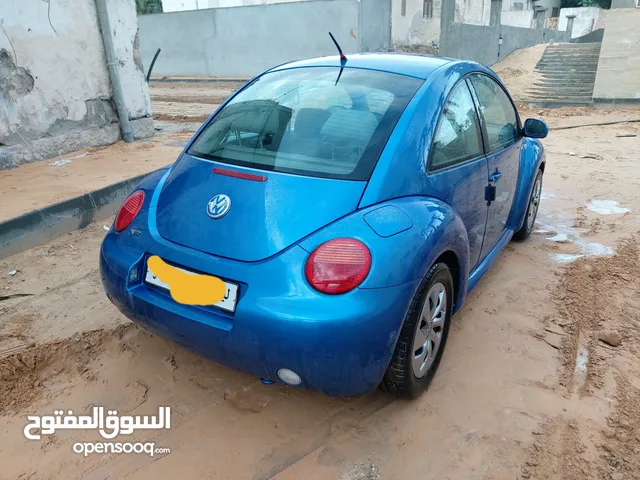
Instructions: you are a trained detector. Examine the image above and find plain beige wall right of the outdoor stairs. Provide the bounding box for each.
[593,8,640,102]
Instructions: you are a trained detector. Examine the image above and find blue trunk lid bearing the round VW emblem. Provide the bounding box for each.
[156,154,367,262]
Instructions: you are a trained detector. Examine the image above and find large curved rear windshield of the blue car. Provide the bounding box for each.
[189,67,423,180]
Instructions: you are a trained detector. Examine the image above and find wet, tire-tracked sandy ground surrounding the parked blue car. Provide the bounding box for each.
[0,111,640,480]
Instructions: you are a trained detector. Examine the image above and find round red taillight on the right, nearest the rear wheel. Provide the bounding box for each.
[304,238,371,294]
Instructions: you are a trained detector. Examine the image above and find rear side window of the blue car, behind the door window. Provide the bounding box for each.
[429,80,483,170]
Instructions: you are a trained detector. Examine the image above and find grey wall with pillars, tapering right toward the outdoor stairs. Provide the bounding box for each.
[440,1,570,66]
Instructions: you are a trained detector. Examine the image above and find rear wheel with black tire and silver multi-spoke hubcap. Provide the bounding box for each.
[381,263,454,398]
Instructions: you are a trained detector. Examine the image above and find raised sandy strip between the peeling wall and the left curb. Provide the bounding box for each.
[0,132,190,221]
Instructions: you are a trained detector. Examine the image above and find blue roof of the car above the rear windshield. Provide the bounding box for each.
[269,53,462,80]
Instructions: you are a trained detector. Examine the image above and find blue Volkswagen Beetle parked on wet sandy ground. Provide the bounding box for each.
[100,54,548,397]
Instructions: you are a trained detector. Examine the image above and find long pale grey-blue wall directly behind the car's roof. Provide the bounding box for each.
[138,0,384,77]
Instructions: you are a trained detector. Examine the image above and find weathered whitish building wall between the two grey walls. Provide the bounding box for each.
[391,0,442,49]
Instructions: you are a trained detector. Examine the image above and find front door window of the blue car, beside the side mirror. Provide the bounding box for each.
[470,75,518,153]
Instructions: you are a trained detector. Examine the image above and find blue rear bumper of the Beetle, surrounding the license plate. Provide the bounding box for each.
[100,232,419,396]
